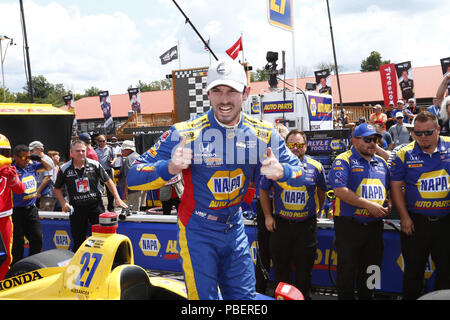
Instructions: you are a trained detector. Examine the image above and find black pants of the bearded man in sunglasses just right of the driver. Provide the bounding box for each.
[270,216,317,299]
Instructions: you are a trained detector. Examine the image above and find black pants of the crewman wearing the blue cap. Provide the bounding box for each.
[334,217,384,300]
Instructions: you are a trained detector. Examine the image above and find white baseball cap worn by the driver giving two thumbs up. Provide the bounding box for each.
[206,60,247,92]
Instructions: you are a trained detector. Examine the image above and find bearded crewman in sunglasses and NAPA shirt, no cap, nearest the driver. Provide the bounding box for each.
[259,130,327,300]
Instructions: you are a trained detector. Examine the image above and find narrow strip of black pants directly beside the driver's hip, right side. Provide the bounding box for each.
[255,199,271,294]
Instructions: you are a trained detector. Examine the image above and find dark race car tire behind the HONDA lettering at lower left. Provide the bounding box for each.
[5,249,74,279]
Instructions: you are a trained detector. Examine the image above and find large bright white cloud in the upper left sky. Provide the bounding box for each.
[0,1,146,93]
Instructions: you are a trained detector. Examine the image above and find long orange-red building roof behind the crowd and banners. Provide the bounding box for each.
[71,65,442,120]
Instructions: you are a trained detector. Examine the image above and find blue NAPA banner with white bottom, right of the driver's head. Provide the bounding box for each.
[308,96,333,130]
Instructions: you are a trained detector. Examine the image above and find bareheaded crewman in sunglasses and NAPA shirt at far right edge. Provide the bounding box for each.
[390,111,450,300]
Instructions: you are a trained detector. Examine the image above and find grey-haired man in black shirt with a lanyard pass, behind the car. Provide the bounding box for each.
[55,140,128,252]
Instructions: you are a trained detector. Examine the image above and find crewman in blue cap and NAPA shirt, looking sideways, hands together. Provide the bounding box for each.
[328,123,391,300]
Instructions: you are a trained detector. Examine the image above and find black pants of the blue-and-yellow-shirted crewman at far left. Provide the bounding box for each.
[11,205,42,265]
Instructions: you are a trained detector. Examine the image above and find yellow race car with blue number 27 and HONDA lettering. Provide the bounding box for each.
[0,213,187,300]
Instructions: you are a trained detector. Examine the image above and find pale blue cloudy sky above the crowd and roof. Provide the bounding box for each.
[0,0,450,94]
